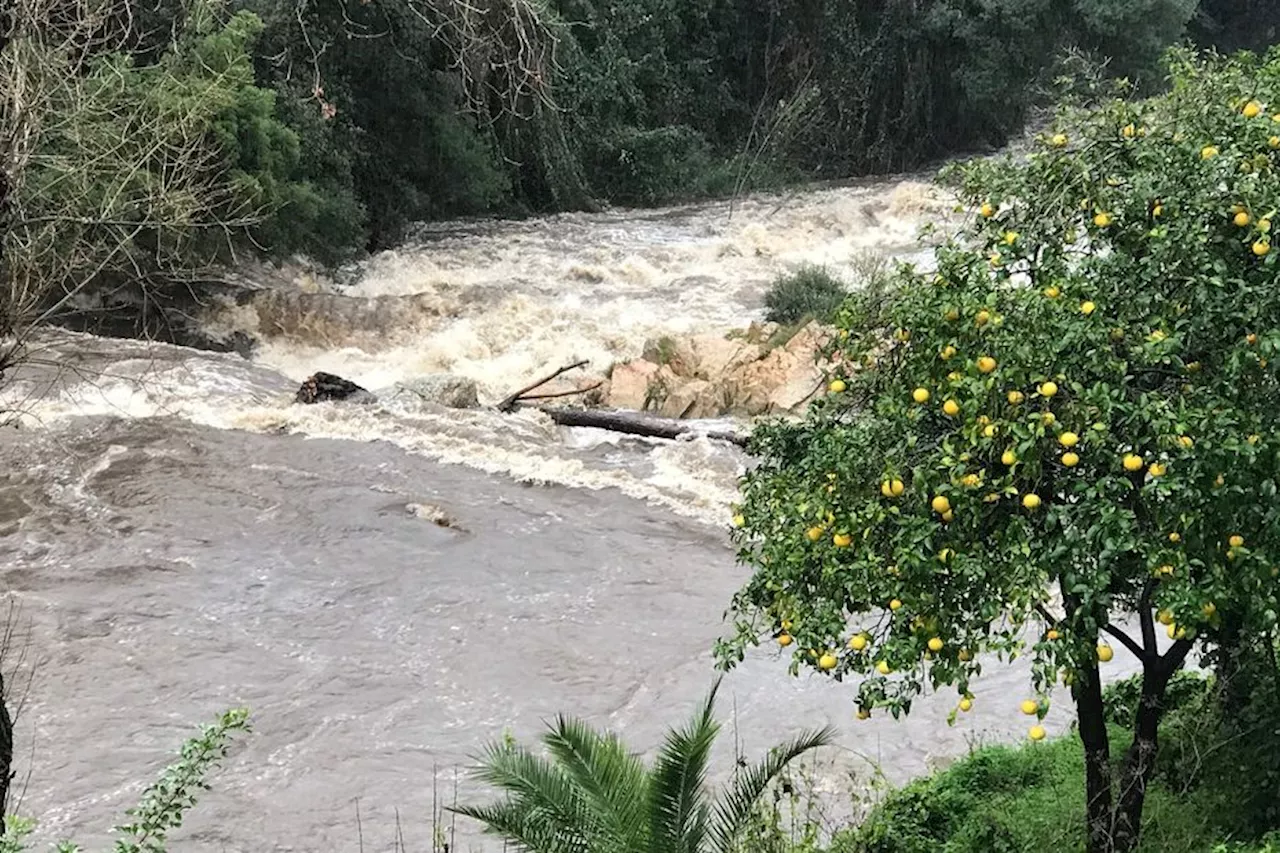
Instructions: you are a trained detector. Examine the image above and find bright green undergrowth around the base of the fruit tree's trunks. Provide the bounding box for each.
[831,674,1276,853]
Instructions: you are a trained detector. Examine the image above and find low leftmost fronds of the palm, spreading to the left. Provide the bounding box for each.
[451,743,599,853]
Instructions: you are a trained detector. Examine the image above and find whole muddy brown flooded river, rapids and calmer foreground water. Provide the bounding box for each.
[0,178,1133,852]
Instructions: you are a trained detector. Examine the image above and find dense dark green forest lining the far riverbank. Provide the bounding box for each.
[0,0,1280,345]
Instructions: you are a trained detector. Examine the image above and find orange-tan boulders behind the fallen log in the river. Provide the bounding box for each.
[607,323,829,418]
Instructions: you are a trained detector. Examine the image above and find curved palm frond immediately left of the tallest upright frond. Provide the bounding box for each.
[543,716,649,853]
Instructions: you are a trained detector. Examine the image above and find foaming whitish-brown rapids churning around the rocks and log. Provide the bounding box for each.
[5,181,947,525]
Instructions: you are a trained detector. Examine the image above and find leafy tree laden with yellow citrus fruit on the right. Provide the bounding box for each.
[717,48,1280,852]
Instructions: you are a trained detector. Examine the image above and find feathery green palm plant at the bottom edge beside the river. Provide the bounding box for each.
[456,683,832,853]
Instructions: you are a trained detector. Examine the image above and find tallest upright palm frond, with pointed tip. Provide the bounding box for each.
[649,679,721,853]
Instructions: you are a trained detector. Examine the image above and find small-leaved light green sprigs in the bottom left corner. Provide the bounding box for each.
[0,708,250,853]
